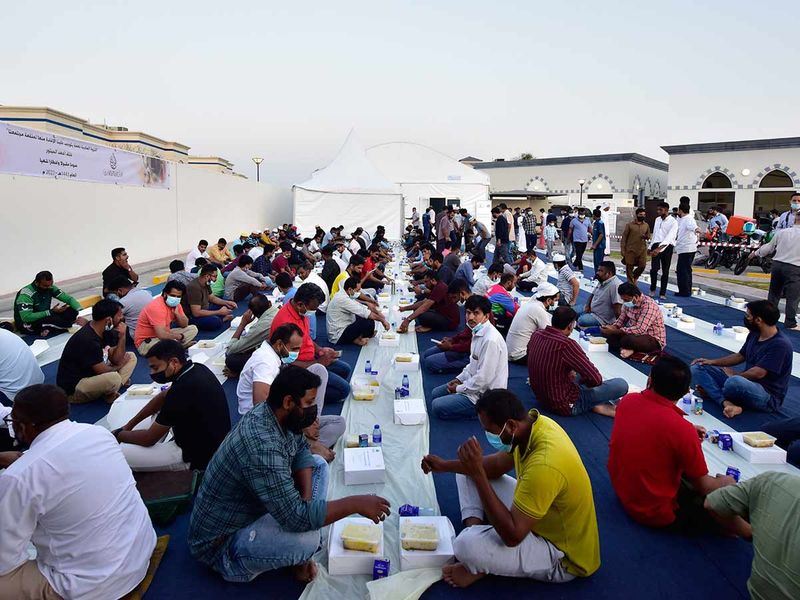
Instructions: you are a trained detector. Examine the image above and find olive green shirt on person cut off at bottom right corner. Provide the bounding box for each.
[706,471,800,600]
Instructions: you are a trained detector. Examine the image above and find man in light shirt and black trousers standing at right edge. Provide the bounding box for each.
[756,203,800,331]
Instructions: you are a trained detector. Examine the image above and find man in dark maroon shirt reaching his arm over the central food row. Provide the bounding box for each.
[397,270,469,333]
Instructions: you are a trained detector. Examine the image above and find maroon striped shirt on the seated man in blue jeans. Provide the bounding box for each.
[528,326,603,416]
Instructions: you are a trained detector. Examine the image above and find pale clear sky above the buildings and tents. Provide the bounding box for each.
[0,0,800,183]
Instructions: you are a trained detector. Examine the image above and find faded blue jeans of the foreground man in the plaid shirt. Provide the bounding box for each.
[211,454,328,583]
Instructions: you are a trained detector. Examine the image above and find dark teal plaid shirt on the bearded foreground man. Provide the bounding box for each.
[189,402,327,565]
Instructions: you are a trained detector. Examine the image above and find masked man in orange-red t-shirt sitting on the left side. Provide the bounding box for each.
[133,281,197,356]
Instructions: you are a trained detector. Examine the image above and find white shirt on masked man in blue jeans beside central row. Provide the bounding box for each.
[456,321,508,404]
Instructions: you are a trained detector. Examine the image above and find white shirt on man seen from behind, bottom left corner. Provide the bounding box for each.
[0,421,156,600]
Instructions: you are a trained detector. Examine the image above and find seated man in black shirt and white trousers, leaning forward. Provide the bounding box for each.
[112,340,231,471]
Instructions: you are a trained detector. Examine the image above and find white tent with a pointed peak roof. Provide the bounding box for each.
[292,131,403,239]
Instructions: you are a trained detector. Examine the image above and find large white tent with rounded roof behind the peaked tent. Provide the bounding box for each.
[367,142,491,229]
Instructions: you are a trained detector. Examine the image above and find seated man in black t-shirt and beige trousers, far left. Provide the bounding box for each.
[56,300,136,404]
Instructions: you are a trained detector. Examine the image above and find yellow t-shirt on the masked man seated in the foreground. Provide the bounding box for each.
[514,409,600,577]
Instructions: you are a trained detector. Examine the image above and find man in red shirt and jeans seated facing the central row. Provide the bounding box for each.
[271,283,352,402]
